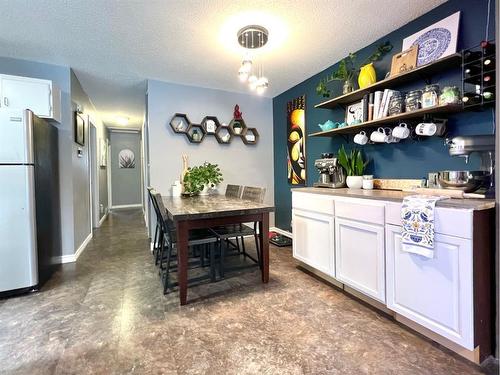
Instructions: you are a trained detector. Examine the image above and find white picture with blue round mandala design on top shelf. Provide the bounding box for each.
[403,12,460,66]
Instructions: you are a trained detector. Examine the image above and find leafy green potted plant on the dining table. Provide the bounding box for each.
[184,162,223,195]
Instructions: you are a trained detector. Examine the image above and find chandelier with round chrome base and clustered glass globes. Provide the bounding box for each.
[237,25,269,95]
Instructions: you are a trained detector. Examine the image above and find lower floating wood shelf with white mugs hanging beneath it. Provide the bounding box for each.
[309,104,463,137]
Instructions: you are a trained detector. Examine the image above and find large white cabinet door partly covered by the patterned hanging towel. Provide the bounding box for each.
[386,225,474,350]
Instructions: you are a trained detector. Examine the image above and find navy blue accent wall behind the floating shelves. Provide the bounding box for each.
[273,0,495,230]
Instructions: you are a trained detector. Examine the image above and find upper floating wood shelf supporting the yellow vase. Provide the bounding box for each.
[314,53,462,109]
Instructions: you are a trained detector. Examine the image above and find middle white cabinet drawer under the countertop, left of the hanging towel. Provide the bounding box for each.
[335,198,385,225]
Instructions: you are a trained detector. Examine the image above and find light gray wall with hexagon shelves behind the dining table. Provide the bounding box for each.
[147,80,274,238]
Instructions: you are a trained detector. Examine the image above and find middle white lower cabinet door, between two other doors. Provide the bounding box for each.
[335,217,385,304]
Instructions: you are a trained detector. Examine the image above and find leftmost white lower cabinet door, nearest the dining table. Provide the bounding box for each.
[292,209,335,277]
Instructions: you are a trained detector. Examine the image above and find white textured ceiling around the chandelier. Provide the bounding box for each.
[0,0,445,126]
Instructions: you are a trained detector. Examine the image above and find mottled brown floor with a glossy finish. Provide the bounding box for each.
[0,210,494,375]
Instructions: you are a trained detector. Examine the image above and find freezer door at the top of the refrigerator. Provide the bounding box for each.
[0,109,33,165]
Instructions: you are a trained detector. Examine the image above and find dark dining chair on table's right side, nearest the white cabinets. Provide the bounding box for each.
[210,186,266,278]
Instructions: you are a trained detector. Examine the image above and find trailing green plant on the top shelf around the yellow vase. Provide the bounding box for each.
[316,41,392,98]
